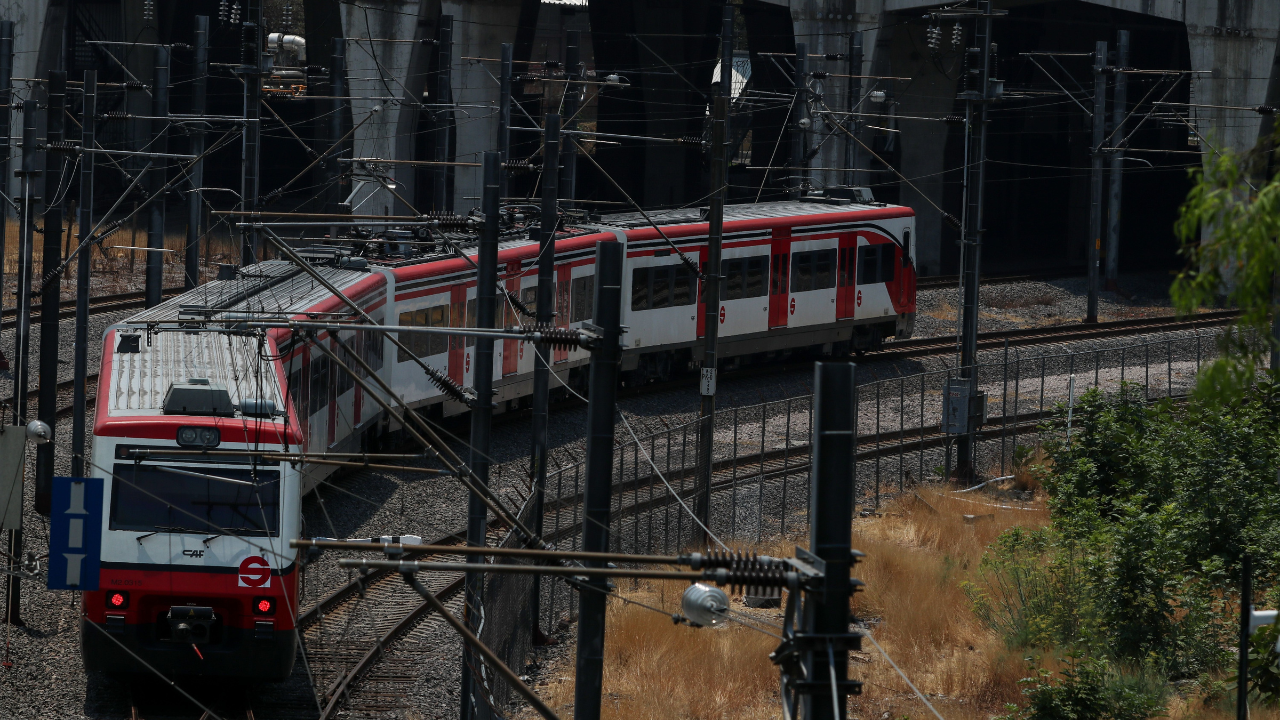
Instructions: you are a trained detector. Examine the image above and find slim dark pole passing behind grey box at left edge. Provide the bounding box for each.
[5,94,40,625]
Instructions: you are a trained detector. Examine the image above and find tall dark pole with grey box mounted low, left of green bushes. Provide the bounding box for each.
[956,0,1004,477]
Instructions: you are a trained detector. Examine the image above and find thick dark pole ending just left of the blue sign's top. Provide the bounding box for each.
[36,70,67,515]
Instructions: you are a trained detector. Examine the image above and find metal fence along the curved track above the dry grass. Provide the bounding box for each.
[486,332,1219,681]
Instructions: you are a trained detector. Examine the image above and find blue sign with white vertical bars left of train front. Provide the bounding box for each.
[49,478,102,591]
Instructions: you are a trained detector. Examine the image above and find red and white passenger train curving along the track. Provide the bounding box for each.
[82,194,915,679]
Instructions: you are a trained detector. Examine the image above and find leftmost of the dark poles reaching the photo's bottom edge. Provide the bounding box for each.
[462,152,502,720]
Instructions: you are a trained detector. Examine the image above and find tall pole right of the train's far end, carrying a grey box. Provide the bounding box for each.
[956,7,993,477]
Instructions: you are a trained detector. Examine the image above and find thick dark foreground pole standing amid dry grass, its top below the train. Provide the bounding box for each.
[804,363,858,720]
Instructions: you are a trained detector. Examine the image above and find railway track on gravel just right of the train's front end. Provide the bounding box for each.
[298,523,502,720]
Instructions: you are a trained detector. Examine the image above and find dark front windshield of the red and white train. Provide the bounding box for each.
[110,462,280,536]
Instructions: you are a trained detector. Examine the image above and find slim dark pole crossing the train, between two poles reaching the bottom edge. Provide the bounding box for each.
[530,113,559,638]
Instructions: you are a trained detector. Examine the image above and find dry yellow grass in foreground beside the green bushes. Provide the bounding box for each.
[519,489,1048,720]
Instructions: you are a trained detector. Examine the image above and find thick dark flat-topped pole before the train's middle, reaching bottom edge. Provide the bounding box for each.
[573,242,622,720]
